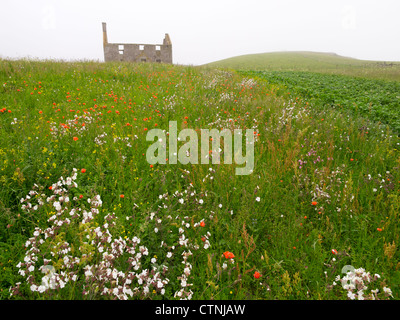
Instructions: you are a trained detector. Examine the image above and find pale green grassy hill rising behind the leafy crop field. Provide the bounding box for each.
[207,51,400,80]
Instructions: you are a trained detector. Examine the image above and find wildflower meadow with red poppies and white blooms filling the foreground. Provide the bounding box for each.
[0,60,400,300]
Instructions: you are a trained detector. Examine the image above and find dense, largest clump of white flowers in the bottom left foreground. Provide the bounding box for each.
[10,169,169,300]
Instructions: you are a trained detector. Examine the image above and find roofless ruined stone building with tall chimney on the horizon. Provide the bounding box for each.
[103,22,172,63]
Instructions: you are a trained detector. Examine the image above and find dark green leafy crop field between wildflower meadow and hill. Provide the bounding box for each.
[247,71,400,132]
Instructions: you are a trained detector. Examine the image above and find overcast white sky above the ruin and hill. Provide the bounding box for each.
[0,0,400,65]
